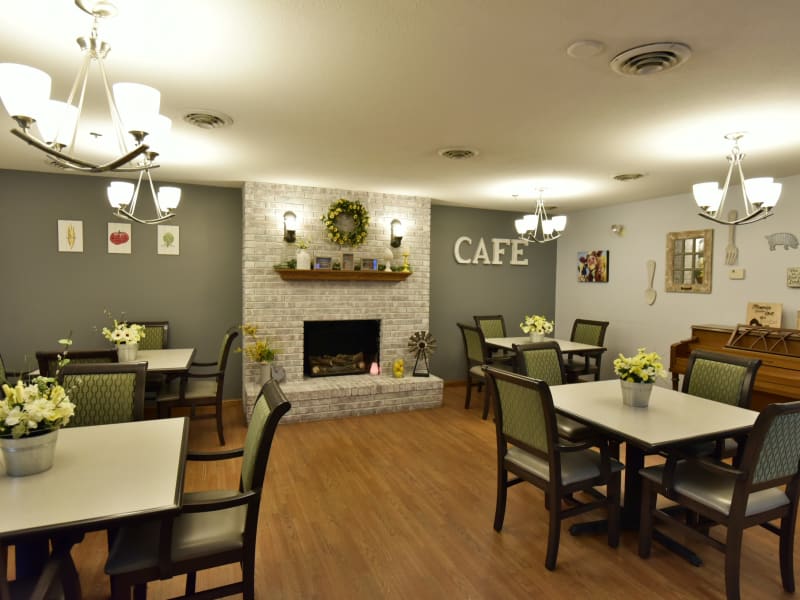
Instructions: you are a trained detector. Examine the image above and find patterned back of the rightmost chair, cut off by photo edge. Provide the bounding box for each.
[742,402,800,485]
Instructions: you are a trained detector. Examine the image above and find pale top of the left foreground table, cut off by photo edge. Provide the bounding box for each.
[0,417,189,538]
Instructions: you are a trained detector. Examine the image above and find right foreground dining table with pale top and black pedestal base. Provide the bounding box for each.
[550,379,758,564]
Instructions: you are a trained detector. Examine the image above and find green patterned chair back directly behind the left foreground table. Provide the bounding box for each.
[59,362,147,427]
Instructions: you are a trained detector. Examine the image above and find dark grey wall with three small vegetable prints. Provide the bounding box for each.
[0,170,242,398]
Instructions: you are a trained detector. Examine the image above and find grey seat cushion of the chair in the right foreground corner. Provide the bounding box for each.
[639,461,789,516]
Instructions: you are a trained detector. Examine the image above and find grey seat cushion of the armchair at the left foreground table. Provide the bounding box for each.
[105,490,247,575]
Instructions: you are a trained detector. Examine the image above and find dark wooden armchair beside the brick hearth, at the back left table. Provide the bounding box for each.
[156,327,239,446]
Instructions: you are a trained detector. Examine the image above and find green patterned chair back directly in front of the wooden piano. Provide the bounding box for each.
[682,350,761,408]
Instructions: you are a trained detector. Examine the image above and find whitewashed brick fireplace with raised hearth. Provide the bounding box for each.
[242,183,442,420]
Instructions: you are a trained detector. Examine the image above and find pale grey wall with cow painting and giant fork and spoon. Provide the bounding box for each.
[556,176,800,385]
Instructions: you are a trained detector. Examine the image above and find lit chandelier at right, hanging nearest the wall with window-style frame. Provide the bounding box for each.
[692,132,782,225]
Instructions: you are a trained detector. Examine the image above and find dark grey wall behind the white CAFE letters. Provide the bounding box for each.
[430,206,556,381]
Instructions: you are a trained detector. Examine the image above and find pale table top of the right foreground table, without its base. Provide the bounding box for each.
[550,379,758,449]
